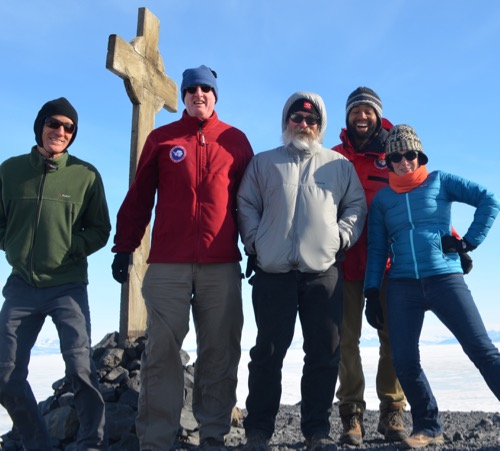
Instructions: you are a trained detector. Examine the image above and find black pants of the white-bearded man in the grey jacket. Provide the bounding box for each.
[244,266,342,438]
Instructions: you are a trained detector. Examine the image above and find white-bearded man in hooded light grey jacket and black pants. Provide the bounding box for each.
[238,92,366,450]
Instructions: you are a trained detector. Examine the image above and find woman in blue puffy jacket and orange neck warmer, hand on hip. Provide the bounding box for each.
[365,125,500,448]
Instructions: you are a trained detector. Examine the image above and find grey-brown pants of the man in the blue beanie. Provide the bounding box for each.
[136,263,243,451]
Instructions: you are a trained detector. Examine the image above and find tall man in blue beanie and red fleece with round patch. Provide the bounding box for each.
[112,66,253,451]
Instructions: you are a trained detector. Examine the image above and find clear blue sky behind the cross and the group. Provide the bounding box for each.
[0,0,500,347]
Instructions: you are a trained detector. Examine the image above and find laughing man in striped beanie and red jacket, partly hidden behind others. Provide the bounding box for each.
[333,87,407,445]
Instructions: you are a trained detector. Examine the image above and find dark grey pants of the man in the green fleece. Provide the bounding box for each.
[0,276,106,451]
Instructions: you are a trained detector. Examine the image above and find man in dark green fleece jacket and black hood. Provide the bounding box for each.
[0,97,111,451]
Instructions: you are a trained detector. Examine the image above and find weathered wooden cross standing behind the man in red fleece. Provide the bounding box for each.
[106,8,177,341]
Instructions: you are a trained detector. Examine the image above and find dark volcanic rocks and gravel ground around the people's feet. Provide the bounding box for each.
[0,332,500,451]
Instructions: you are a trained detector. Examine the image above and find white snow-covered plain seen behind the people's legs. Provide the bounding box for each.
[0,343,500,434]
